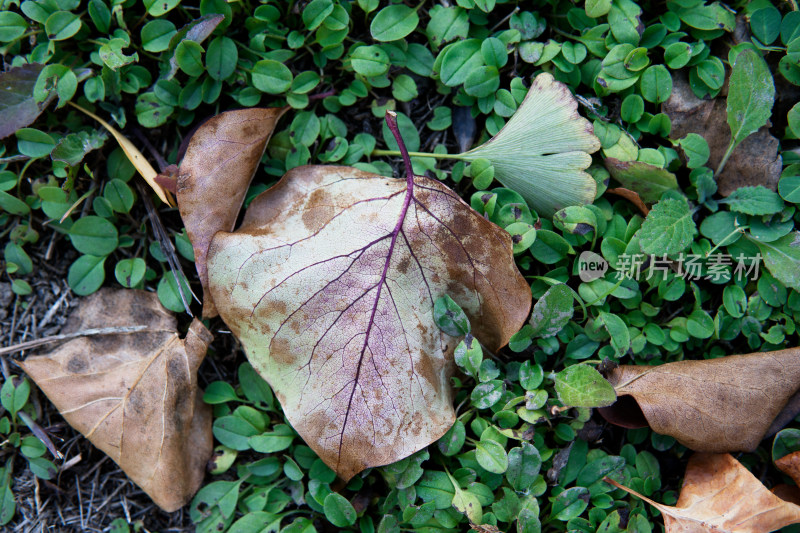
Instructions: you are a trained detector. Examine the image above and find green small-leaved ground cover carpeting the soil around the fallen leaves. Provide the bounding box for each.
[0,0,800,533]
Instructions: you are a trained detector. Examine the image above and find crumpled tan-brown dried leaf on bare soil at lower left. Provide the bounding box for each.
[21,289,213,512]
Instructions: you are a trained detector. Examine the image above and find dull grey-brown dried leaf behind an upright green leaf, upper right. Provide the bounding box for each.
[661,73,782,196]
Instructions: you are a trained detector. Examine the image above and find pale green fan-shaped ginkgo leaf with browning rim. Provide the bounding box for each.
[459,72,600,217]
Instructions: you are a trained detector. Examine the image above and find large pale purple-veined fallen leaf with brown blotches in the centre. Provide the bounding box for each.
[208,166,531,480]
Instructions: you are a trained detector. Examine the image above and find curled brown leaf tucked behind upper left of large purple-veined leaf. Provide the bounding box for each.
[177,107,287,317]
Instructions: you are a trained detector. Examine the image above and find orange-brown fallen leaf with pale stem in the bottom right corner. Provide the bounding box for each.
[605,453,800,533]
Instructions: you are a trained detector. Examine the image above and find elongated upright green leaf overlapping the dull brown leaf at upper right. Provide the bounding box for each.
[727,49,775,151]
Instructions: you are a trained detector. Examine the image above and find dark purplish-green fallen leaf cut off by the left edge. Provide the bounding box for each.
[0,63,55,139]
